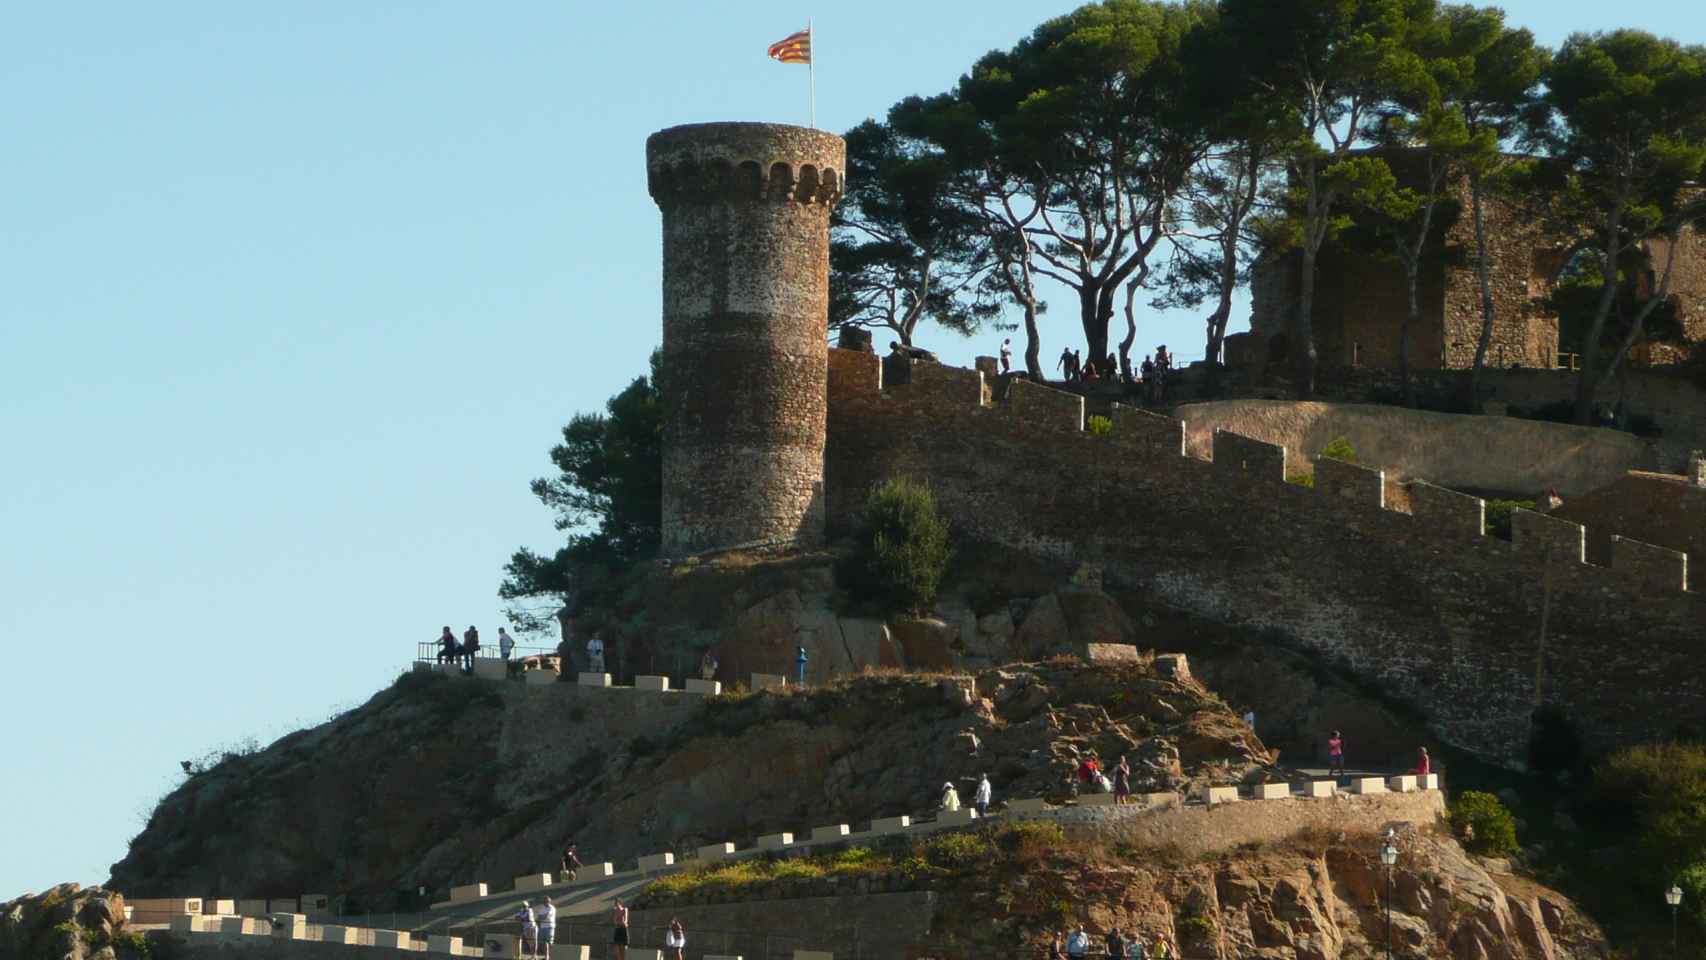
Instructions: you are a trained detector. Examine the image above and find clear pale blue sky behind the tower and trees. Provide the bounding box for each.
[0,0,1706,900]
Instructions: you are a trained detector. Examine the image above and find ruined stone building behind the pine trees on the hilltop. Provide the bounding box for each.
[1227,152,1706,370]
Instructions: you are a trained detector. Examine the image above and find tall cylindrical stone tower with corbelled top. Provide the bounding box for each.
[645,123,846,556]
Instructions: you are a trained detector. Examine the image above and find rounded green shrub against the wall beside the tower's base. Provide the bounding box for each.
[850,477,952,614]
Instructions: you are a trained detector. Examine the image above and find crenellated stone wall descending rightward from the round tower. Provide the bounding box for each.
[824,350,1706,760]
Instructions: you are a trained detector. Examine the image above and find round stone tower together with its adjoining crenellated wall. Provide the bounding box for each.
[647,123,1706,762]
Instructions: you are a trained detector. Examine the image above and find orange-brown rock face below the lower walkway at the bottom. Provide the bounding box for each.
[638,822,1605,960]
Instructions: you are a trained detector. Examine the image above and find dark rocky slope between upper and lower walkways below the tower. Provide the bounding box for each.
[111,658,1268,909]
